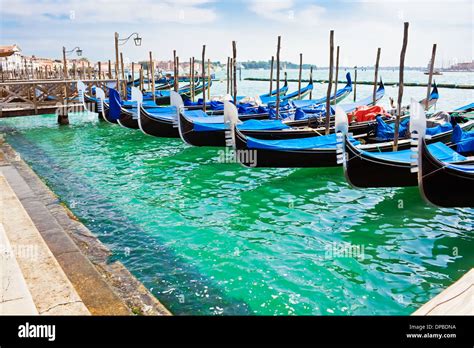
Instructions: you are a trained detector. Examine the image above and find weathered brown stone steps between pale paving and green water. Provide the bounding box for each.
[0,140,172,315]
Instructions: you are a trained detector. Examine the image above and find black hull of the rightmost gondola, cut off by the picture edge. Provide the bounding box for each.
[418,138,474,208]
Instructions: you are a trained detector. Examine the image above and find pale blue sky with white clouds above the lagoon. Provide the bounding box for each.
[0,0,474,66]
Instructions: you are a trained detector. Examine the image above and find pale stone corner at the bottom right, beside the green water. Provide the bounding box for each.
[413,268,474,315]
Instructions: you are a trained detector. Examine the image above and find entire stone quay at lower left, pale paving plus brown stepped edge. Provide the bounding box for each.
[0,141,171,315]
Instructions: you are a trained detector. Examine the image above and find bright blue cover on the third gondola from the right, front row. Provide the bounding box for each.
[247,134,359,151]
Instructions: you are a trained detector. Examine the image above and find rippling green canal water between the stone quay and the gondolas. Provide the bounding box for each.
[0,109,474,315]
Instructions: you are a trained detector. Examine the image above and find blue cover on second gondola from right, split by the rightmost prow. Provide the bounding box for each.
[362,142,466,164]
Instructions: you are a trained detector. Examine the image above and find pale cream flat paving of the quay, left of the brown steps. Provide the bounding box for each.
[0,175,89,315]
